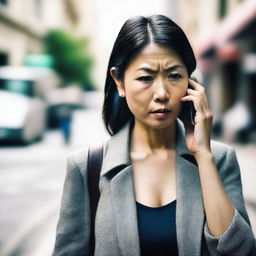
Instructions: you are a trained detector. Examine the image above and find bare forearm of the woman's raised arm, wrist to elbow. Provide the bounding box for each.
[195,152,235,237]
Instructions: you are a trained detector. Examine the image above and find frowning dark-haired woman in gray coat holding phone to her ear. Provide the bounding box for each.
[53,15,256,256]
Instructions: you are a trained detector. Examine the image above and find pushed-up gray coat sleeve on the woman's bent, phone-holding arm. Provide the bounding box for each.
[204,148,256,256]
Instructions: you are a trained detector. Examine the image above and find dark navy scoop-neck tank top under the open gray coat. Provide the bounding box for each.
[136,200,178,256]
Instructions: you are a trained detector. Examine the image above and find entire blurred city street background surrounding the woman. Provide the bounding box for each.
[0,0,256,256]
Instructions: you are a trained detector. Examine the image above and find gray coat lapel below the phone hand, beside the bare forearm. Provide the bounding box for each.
[176,120,204,256]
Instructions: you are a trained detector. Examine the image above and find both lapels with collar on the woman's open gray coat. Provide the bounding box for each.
[101,119,204,256]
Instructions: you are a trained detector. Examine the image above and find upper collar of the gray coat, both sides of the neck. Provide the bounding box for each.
[101,119,195,176]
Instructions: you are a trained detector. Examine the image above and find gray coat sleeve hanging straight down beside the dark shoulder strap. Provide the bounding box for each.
[52,148,90,256]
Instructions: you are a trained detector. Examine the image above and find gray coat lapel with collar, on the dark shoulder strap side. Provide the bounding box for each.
[100,123,140,256]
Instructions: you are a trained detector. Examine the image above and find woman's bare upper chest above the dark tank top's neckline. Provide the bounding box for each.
[132,151,176,207]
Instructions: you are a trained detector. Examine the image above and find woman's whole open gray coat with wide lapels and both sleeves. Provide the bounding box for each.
[53,120,256,256]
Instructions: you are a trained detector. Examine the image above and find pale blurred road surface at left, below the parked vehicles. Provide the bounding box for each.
[0,132,69,256]
